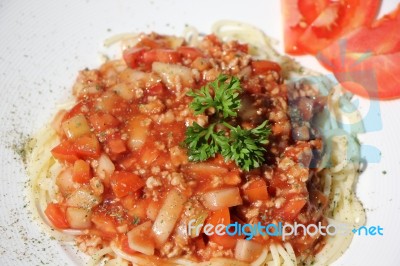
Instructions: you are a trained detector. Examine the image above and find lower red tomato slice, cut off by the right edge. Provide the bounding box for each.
[317,5,400,99]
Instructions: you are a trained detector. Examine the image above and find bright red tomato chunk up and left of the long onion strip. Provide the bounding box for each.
[111,171,145,198]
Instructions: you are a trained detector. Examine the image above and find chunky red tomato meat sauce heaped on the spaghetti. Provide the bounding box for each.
[46,31,326,261]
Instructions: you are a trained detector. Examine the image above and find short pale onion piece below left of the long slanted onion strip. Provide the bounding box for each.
[127,221,154,256]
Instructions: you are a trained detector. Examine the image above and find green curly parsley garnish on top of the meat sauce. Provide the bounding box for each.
[184,75,271,171]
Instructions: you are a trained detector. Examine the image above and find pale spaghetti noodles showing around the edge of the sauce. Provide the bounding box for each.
[28,21,365,266]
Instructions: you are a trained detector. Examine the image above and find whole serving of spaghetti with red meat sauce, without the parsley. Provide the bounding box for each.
[28,21,365,265]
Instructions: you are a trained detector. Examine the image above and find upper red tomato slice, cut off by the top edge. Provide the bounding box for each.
[282,0,381,55]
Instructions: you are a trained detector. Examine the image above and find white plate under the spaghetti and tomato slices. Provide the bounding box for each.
[0,0,400,265]
